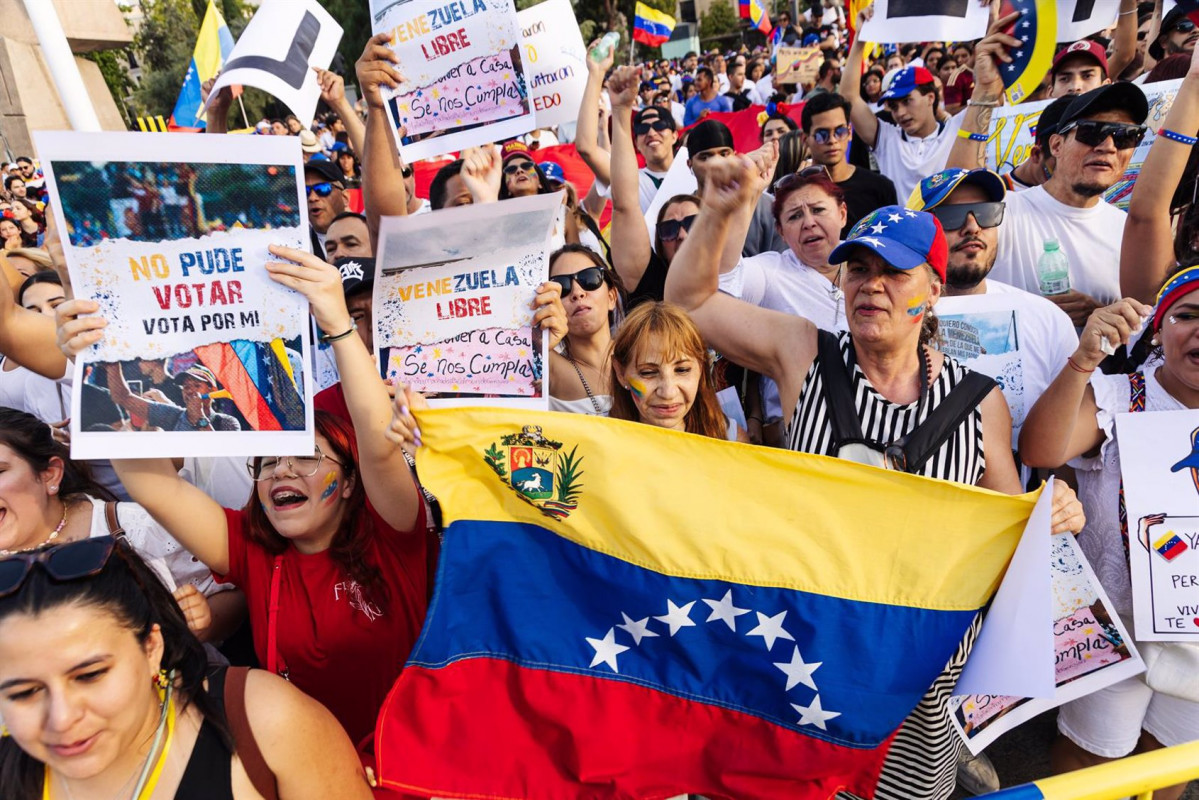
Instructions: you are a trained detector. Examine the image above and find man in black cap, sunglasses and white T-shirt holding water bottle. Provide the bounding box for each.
[992,83,1149,327]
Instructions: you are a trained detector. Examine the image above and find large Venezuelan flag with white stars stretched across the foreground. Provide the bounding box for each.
[375,409,1034,800]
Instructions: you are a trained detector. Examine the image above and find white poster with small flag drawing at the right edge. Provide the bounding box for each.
[1116,410,1199,643]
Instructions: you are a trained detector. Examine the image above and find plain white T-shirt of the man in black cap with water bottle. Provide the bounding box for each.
[990,185,1127,305]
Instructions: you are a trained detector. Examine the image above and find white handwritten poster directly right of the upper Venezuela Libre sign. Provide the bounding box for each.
[517,0,588,128]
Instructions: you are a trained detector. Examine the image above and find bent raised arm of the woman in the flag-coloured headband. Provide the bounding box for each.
[1020,297,1152,469]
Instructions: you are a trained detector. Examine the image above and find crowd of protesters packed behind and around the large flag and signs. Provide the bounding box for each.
[0,0,1199,800]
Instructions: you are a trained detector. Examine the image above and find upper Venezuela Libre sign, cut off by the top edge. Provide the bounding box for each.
[370,0,537,162]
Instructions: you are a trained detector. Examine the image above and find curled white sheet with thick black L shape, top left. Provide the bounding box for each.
[201,0,342,125]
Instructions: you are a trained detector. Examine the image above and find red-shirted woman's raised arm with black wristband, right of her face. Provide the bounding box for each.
[266,245,421,530]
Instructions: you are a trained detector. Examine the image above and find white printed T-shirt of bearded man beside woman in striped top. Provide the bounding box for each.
[933,281,1078,450]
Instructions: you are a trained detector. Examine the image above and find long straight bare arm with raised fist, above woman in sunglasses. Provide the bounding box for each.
[609,66,651,291]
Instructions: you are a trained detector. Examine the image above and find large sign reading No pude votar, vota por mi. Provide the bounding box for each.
[36,133,314,458]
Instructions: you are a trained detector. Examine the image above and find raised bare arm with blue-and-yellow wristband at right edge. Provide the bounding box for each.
[1120,48,1199,302]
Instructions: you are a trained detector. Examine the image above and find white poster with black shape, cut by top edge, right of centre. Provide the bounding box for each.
[860,0,990,44]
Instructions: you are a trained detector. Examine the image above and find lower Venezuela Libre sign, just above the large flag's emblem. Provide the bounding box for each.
[373,194,562,410]
